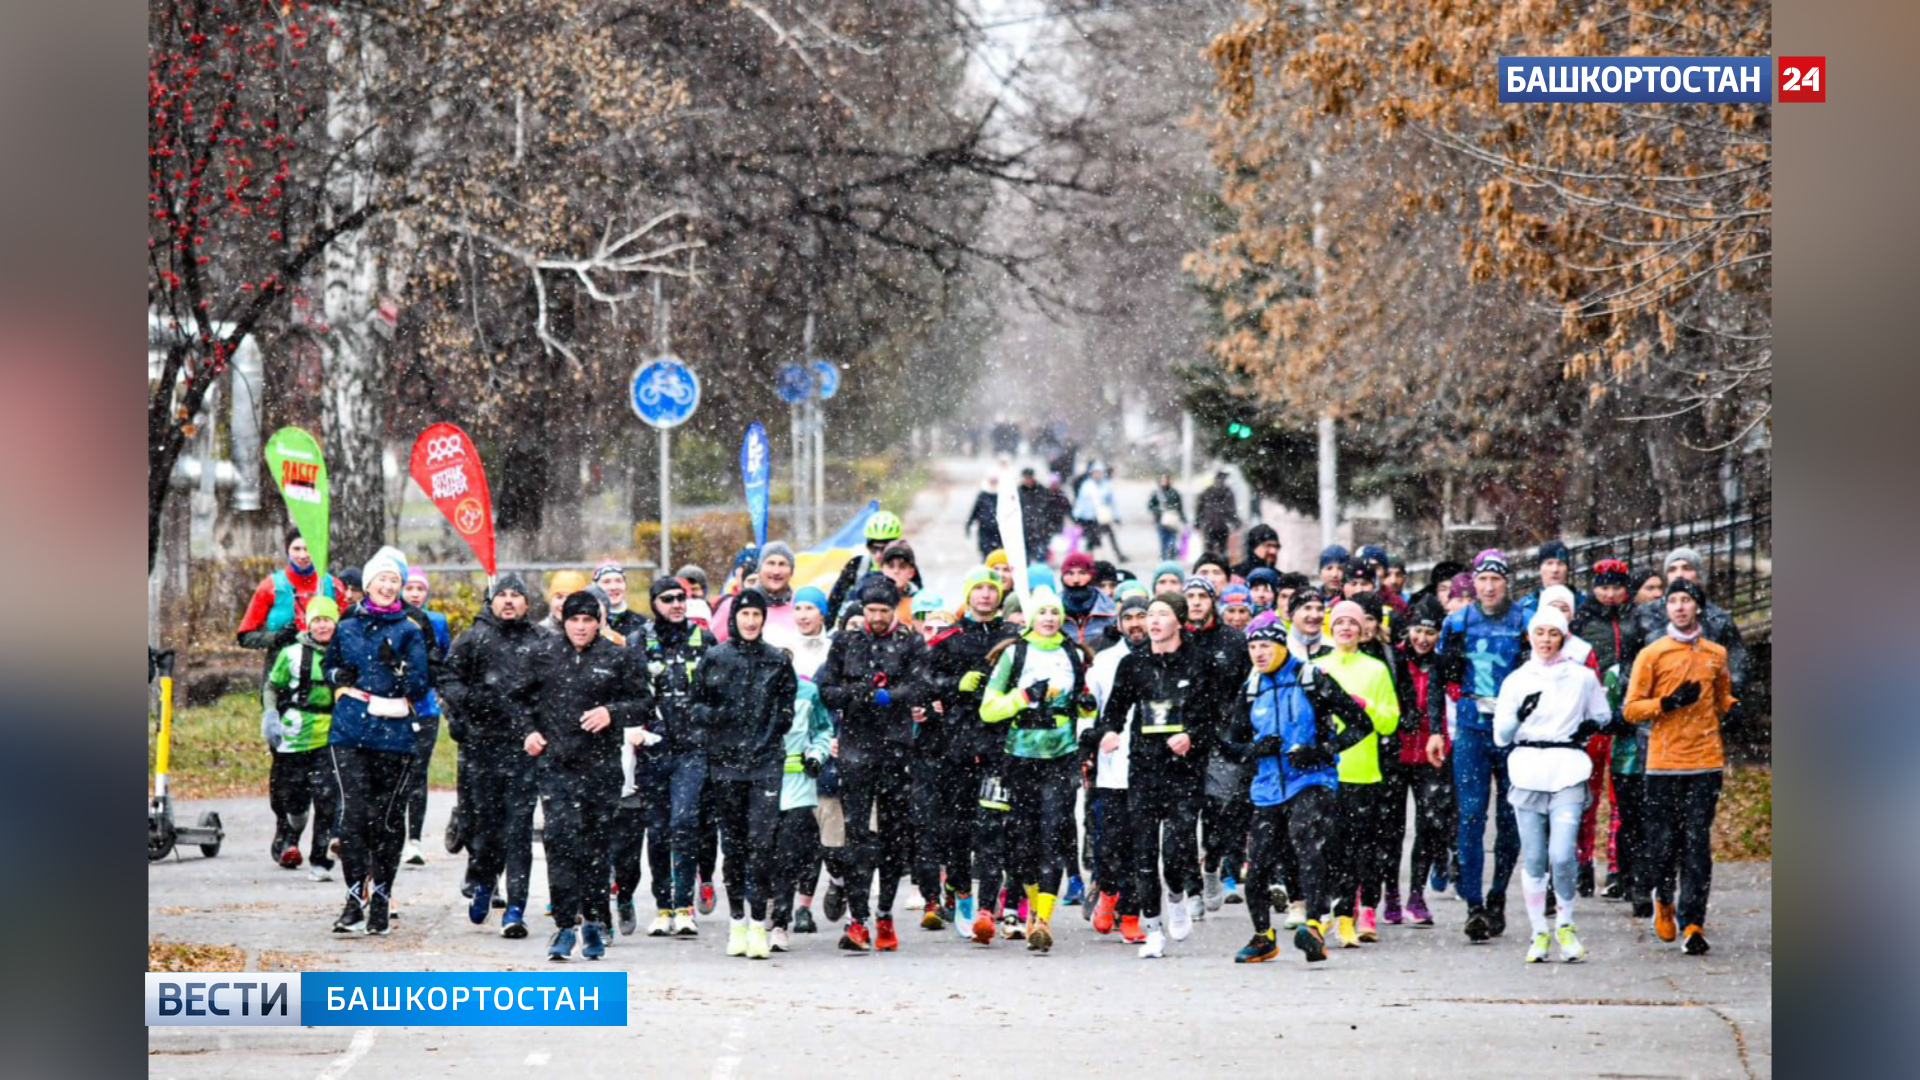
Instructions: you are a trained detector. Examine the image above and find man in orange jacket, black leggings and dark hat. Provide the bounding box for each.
[1620,578,1736,957]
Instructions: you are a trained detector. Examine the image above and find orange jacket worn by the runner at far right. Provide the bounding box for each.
[1620,634,1734,773]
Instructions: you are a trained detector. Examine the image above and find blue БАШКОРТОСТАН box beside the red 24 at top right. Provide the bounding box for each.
[1500,56,1774,104]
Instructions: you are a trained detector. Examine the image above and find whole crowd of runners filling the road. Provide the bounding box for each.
[240,471,1745,963]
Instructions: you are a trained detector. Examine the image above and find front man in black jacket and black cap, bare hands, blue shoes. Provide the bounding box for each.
[520,590,653,961]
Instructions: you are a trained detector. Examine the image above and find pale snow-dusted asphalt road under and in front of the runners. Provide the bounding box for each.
[148,457,1772,1080]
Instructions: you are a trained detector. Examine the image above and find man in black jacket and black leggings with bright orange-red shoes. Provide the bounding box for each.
[814,578,925,951]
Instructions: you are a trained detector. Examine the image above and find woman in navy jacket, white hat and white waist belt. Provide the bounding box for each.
[323,548,428,934]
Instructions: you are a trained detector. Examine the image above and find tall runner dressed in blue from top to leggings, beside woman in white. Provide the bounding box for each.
[1427,548,1526,942]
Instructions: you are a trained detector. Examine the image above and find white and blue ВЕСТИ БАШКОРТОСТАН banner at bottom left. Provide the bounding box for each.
[146,970,626,1028]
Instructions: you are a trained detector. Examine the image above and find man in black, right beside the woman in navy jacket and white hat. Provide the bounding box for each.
[440,573,541,938]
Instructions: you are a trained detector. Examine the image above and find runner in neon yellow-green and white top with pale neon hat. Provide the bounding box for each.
[979,586,1092,953]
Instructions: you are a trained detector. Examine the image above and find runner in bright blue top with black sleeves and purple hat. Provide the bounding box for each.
[1223,623,1373,963]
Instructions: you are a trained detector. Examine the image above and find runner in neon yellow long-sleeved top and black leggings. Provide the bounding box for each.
[1309,600,1400,949]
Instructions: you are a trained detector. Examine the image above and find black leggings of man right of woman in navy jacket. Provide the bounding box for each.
[461,736,540,911]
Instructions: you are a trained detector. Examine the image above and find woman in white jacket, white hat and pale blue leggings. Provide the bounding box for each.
[1494,603,1613,963]
